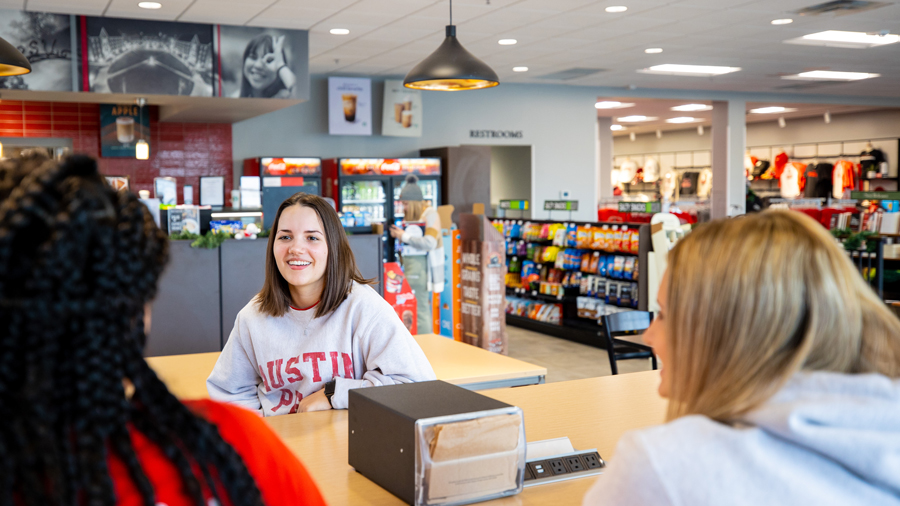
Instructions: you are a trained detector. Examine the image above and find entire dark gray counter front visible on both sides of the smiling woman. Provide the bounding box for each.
[144,234,384,357]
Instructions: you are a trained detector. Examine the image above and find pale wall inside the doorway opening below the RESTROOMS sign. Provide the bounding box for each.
[491,146,534,218]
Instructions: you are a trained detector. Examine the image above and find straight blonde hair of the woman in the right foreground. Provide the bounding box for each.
[665,211,900,421]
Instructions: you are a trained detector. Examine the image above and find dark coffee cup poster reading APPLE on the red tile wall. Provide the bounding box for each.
[100,104,152,158]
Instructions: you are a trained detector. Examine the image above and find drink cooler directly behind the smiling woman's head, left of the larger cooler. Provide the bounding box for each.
[244,157,322,229]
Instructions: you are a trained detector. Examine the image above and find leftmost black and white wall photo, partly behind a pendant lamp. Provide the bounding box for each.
[0,9,72,91]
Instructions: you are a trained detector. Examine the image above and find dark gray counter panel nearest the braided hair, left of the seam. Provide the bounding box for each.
[144,241,222,357]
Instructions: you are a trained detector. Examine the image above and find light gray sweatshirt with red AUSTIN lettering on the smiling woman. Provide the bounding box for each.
[206,282,435,416]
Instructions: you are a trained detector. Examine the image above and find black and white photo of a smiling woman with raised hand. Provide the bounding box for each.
[217,25,309,99]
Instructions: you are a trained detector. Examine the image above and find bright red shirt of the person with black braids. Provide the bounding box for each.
[107,400,325,506]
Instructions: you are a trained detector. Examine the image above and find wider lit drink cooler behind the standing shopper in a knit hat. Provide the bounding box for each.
[322,158,441,262]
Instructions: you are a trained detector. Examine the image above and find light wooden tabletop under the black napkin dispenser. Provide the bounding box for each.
[266,371,666,506]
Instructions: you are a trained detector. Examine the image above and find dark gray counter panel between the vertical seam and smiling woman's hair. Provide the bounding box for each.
[220,239,268,346]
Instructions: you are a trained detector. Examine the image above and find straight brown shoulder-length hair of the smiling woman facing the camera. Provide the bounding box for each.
[257,193,375,318]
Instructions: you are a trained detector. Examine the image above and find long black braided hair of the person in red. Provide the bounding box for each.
[0,154,262,506]
